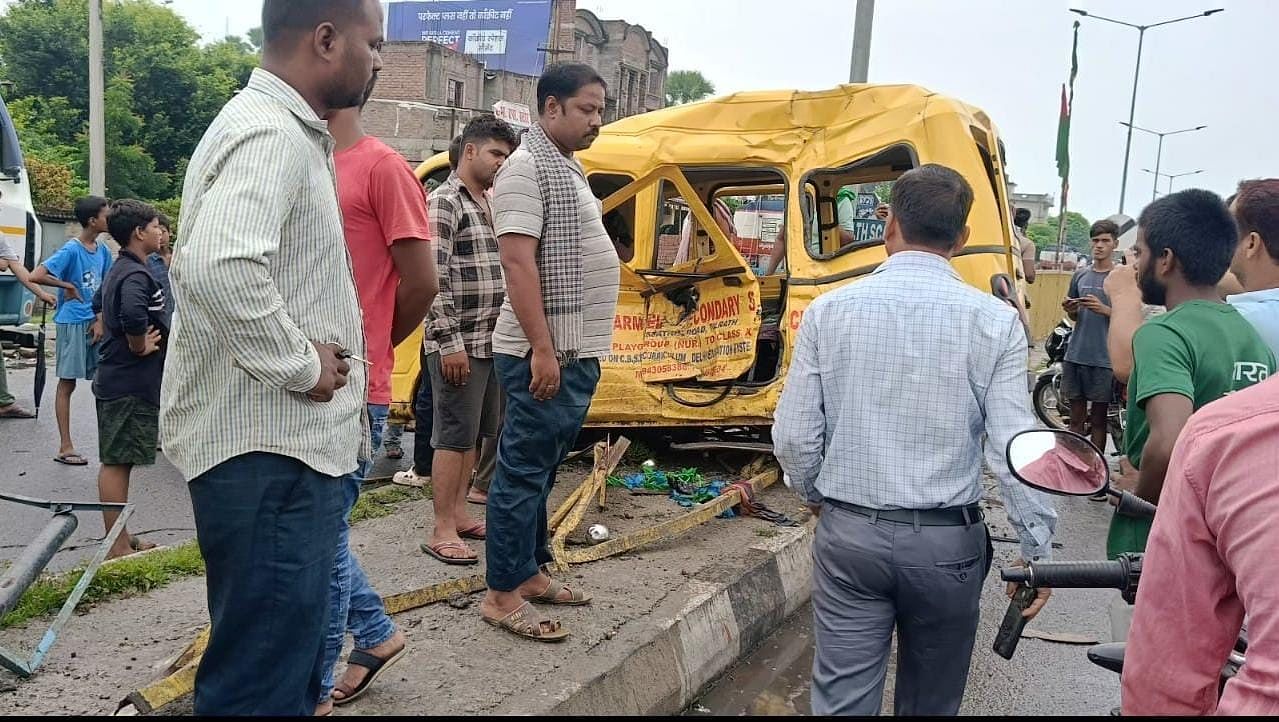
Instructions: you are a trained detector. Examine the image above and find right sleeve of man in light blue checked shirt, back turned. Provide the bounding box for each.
[984,319,1056,561]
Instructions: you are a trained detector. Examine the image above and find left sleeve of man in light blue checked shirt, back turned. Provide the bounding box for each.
[773,299,826,505]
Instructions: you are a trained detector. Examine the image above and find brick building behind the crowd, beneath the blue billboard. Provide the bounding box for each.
[365,0,668,162]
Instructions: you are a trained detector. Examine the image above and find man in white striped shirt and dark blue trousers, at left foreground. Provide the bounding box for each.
[161,0,382,716]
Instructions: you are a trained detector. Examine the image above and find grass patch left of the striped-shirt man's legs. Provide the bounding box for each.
[0,539,205,629]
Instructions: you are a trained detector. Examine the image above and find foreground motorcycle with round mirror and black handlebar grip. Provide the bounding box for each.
[994,429,1248,714]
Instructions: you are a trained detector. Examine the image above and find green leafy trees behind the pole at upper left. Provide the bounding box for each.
[0,0,257,201]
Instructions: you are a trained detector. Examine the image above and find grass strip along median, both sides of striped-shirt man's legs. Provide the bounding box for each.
[0,486,431,629]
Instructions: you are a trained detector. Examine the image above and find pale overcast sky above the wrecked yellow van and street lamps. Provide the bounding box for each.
[4,0,1279,219]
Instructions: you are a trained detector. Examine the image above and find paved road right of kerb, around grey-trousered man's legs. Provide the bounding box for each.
[688,498,1119,716]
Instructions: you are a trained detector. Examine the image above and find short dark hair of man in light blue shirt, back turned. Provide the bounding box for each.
[891,164,972,250]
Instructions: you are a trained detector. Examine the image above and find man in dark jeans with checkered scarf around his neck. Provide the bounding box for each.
[480,64,619,641]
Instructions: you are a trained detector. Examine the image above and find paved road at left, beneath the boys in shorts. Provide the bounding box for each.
[0,368,413,570]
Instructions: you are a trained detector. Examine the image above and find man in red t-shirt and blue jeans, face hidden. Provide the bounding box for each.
[316,88,439,714]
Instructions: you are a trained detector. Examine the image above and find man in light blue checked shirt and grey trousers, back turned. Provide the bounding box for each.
[773,165,1056,716]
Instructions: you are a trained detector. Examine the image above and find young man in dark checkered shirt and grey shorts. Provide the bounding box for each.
[422,115,519,565]
